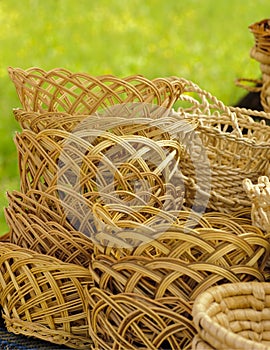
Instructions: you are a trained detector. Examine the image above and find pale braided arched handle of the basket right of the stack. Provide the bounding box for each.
[174,78,243,138]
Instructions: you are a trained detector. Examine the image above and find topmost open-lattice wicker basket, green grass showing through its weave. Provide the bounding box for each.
[8,67,186,114]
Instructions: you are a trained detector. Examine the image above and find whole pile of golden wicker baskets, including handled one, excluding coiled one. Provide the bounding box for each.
[0,68,270,350]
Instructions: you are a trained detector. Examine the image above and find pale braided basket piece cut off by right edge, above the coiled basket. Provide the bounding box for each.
[243,176,270,233]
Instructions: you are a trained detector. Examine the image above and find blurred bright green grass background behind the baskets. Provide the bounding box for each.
[0,0,270,233]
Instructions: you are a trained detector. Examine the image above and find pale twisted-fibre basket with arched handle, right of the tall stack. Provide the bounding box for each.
[177,79,270,212]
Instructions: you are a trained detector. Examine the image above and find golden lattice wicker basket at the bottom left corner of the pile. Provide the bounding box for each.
[0,242,93,349]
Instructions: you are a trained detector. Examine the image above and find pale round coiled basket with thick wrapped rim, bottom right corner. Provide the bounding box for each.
[192,282,270,350]
